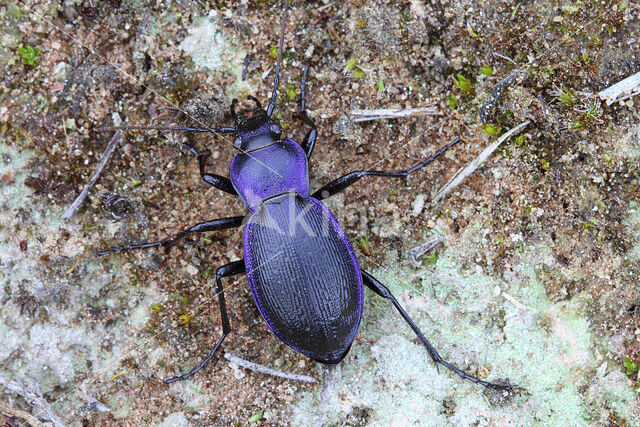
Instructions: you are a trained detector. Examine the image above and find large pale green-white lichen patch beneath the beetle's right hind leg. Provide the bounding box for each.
[294,227,640,425]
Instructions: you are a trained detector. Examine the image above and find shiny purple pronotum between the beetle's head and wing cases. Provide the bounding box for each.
[229,139,309,212]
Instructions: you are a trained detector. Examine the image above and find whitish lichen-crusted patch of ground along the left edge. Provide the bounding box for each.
[0,140,168,421]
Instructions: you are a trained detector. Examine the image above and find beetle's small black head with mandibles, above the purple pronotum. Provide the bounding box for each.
[231,96,282,151]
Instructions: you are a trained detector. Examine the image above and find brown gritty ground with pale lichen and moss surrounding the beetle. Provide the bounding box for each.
[0,0,640,426]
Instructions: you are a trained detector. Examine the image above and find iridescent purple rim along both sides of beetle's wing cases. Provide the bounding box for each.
[243,197,364,360]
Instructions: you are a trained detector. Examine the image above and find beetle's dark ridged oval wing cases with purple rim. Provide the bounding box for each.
[244,193,363,363]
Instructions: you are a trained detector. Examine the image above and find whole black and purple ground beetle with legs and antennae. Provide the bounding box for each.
[98,1,510,390]
